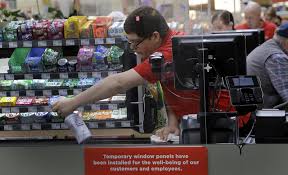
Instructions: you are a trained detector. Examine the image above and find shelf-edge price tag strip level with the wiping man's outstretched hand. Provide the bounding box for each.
[0,101,125,113]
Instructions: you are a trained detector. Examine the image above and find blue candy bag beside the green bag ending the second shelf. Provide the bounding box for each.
[93,45,109,71]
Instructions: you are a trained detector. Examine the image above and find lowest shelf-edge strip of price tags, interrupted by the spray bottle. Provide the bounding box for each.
[0,119,133,131]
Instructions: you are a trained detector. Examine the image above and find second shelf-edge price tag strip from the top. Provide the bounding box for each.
[0,71,120,80]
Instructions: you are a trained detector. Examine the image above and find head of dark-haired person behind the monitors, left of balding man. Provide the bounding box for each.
[211,10,235,31]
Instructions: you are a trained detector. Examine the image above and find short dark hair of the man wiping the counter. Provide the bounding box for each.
[124,6,169,38]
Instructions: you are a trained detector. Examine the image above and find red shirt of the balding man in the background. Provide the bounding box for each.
[235,21,277,40]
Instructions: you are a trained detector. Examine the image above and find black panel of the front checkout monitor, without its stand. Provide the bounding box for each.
[172,34,246,90]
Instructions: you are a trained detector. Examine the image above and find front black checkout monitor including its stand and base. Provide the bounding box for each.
[172,34,246,143]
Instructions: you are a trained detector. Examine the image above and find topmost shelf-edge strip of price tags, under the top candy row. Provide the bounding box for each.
[0,37,123,48]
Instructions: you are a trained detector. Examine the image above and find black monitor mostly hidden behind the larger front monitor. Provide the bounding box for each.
[212,29,265,55]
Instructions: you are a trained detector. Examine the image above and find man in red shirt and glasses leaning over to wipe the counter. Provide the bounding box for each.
[53,6,199,139]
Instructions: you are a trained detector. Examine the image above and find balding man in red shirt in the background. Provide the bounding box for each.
[235,1,277,40]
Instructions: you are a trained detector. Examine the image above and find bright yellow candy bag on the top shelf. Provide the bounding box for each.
[64,16,87,38]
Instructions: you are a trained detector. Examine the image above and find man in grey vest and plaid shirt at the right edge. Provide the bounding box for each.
[247,23,288,108]
